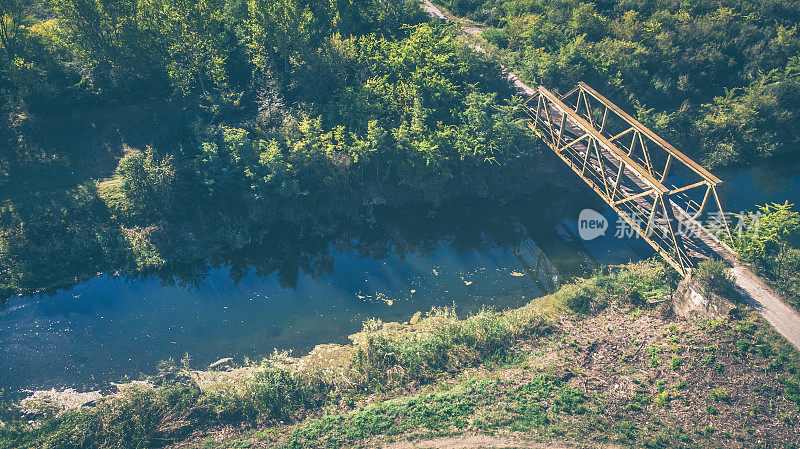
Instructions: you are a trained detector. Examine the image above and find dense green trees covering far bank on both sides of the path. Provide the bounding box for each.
[0,0,800,293]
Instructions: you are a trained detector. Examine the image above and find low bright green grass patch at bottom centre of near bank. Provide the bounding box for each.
[283,374,588,449]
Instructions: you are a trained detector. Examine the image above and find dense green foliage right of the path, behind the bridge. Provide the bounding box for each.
[454,0,800,165]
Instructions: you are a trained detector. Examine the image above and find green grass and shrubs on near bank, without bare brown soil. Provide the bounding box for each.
[6,264,800,449]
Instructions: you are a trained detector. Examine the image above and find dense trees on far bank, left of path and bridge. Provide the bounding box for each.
[0,0,532,297]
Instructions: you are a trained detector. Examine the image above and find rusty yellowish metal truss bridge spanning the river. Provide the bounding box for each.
[526,83,735,275]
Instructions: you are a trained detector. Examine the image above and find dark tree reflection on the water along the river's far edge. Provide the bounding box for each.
[150,200,596,288]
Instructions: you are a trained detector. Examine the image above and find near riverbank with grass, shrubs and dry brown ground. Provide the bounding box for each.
[0,263,800,447]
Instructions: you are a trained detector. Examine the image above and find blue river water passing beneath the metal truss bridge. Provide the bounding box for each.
[0,153,800,390]
